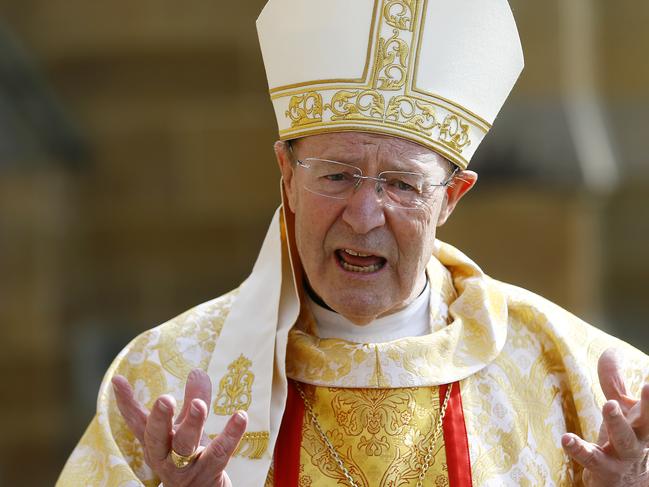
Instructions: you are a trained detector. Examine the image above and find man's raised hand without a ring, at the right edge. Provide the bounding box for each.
[561,349,649,487]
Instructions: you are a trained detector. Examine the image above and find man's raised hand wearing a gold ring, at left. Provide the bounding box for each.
[112,369,248,487]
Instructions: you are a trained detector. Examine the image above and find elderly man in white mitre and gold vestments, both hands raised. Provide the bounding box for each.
[59,0,649,487]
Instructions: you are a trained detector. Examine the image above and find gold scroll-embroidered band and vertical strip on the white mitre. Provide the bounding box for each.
[272,0,480,168]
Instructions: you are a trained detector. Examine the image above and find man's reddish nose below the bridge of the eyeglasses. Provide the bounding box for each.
[343,180,385,235]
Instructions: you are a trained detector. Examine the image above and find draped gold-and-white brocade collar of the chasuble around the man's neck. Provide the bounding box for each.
[286,242,508,388]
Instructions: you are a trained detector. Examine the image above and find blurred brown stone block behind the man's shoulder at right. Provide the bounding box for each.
[438,185,603,322]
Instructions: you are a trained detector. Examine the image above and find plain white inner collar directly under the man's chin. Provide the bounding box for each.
[307,280,430,343]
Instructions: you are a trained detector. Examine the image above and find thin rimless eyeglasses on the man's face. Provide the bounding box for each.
[296,157,458,210]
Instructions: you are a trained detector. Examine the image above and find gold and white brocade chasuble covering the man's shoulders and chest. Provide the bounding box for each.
[57,209,649,487]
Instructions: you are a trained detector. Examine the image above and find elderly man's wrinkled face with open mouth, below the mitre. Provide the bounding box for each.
[277,132,470,324]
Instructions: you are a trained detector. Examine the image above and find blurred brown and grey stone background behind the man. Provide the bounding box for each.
[0,0,649,486]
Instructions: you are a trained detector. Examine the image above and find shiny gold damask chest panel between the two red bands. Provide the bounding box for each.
[299,386,448,487]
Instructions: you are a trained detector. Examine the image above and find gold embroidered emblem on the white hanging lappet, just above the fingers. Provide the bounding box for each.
[214,355,255,416]
